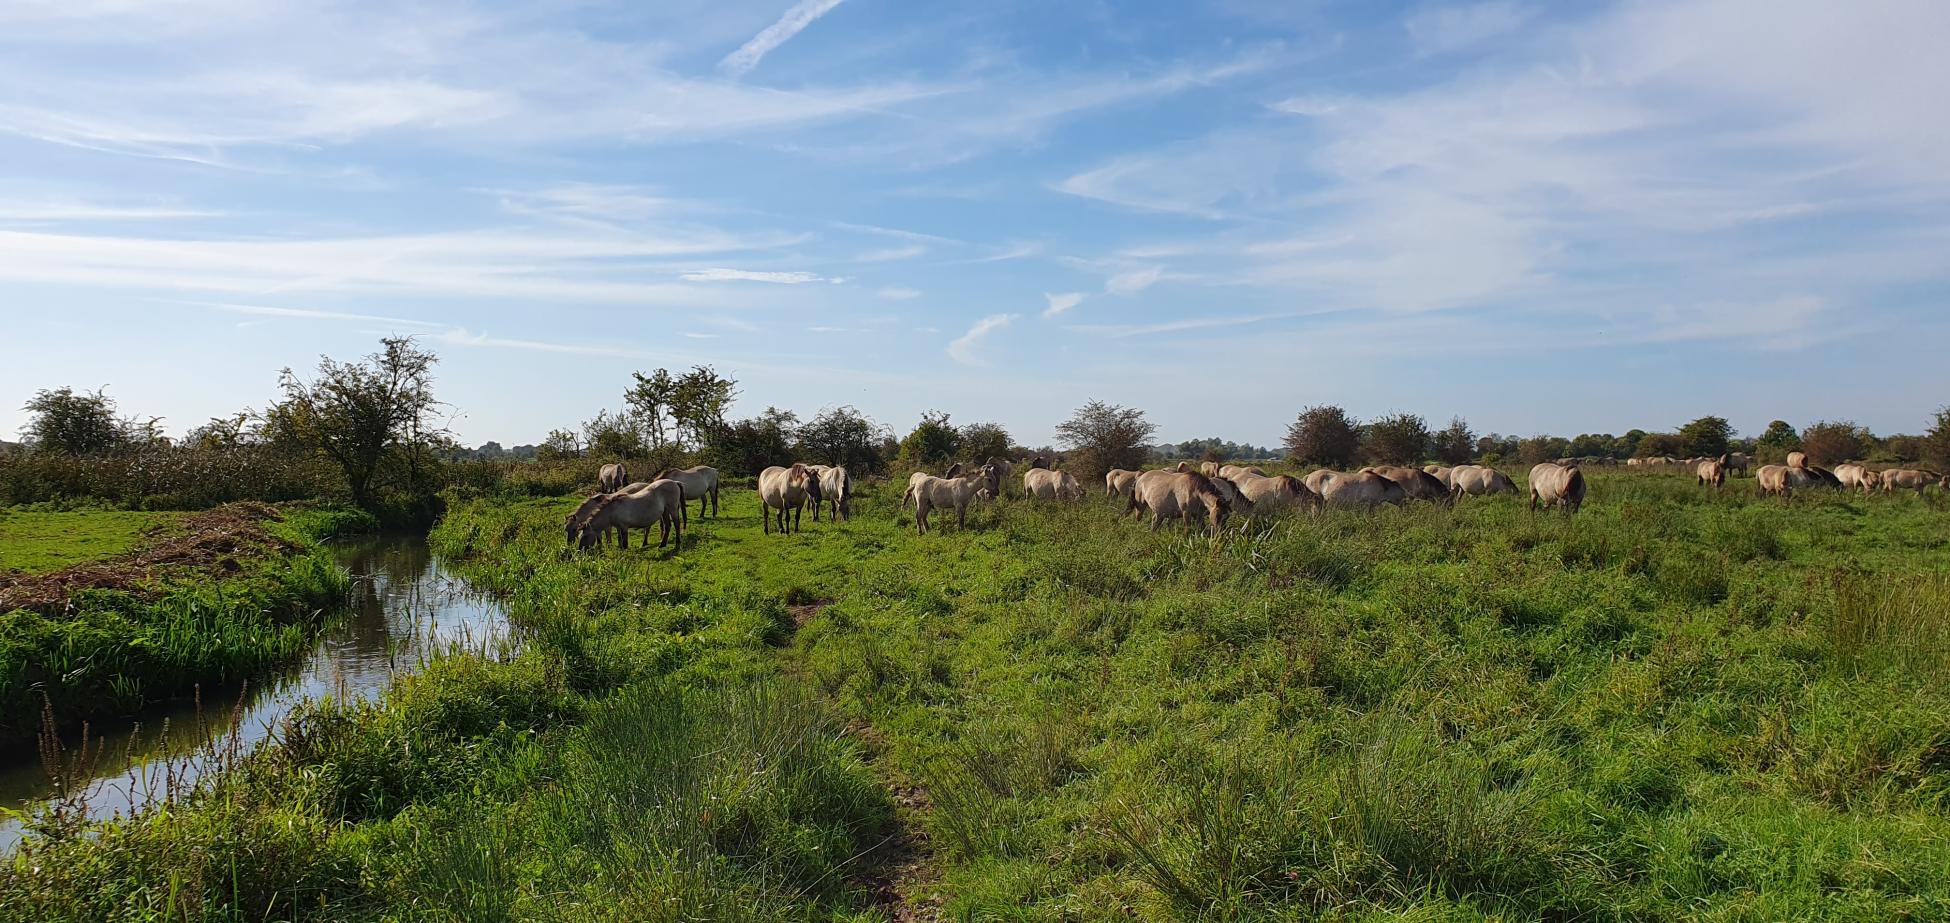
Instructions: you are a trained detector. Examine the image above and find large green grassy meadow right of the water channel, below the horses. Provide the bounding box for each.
[0,474,1950,921]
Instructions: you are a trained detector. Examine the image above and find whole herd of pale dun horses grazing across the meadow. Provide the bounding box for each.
[566,453,1950,548]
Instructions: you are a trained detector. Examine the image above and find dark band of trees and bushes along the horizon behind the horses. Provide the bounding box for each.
[15,338,1950,519]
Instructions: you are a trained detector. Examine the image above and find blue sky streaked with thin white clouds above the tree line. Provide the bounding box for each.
[0,0,1950,445]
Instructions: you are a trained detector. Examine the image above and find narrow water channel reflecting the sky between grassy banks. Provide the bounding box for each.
[0,535,509,853]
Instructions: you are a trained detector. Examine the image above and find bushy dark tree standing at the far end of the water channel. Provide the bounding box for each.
[265,338,439,505]
